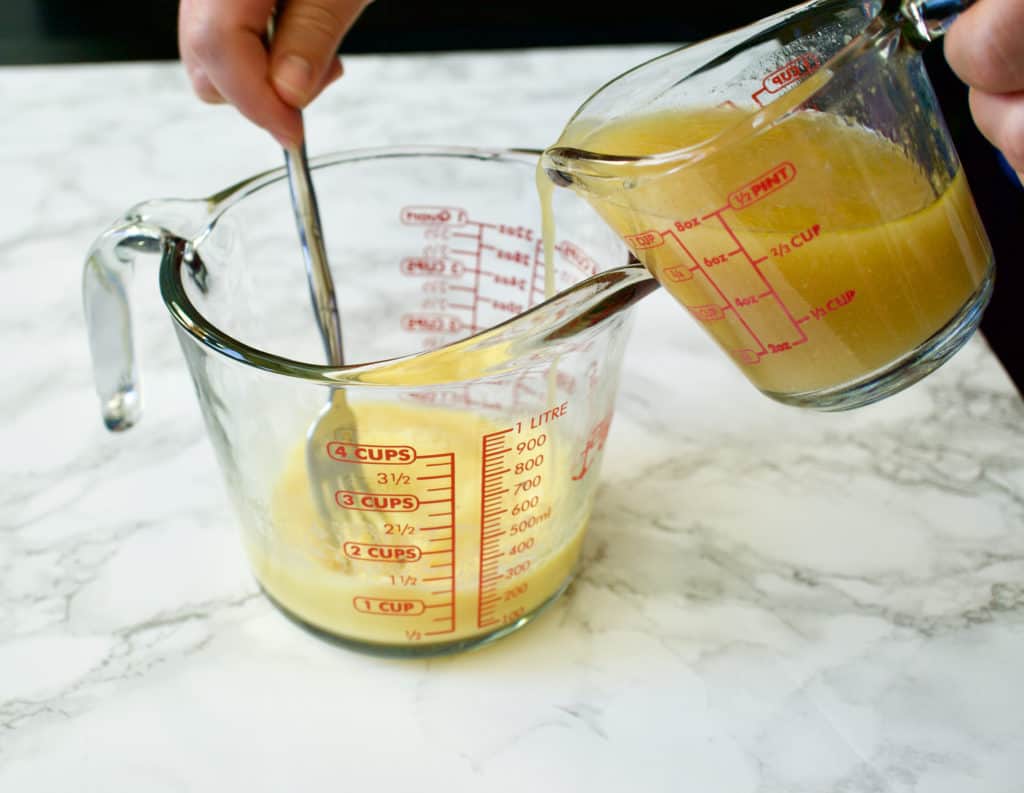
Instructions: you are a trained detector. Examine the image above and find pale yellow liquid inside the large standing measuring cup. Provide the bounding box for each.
[247,403,589,646]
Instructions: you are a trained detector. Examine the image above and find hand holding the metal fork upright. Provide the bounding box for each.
[178,0,371,147]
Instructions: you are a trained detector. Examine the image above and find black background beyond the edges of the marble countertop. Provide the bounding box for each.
[0,0,1024,392]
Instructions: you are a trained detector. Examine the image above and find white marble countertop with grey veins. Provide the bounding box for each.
[0,47,1024,793]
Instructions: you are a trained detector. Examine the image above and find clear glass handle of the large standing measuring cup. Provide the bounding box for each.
[82,201,205,432]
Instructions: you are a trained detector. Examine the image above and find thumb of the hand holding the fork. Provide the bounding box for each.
[270,0,371,108]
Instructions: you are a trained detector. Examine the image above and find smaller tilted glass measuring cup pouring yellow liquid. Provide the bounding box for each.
[543,0,994,410]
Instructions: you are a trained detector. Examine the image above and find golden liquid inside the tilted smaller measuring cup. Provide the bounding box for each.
[559,109,991,394]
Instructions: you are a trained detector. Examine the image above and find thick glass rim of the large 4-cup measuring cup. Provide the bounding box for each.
[160,145,656,387]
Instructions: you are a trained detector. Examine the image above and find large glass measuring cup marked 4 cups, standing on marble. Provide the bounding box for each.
[84,148,656,656]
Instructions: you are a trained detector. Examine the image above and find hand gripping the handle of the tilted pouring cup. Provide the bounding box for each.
[945,0,1024,180]
